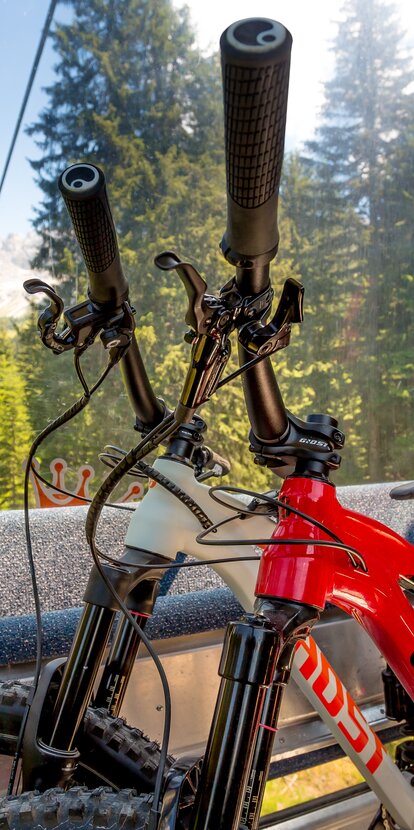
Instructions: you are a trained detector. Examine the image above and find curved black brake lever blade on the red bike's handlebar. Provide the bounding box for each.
[154,251,211,334]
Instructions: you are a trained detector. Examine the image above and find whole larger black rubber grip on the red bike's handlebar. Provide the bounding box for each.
[220,18,292,268]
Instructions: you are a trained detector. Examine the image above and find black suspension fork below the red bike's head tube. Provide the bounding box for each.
[190,599,319,830]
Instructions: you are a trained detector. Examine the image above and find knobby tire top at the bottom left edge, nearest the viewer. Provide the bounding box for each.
[0,787,152,830]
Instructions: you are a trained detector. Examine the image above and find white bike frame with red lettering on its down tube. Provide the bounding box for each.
[126,458,414,830]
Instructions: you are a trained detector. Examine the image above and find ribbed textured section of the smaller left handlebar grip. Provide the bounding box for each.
[64,197,118,274]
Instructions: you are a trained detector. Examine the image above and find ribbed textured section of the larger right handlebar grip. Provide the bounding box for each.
[223,60,289,208]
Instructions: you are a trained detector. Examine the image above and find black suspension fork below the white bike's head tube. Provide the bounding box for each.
[23,548,170,790]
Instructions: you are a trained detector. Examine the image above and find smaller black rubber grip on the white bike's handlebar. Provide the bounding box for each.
[58,163,128,307]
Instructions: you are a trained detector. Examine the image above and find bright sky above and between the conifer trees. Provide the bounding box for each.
[0,0,414,238]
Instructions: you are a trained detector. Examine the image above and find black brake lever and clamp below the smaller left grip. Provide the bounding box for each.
[23,279,135,363]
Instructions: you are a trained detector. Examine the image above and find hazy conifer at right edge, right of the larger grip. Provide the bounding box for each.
[300,0,413,480]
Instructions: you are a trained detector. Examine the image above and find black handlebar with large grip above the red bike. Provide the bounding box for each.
[220,18,292,442]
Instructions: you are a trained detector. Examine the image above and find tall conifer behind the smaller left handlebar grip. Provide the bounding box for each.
[29,0,221,300]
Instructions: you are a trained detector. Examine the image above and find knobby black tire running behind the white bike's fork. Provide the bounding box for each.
[0,680,174,792]
